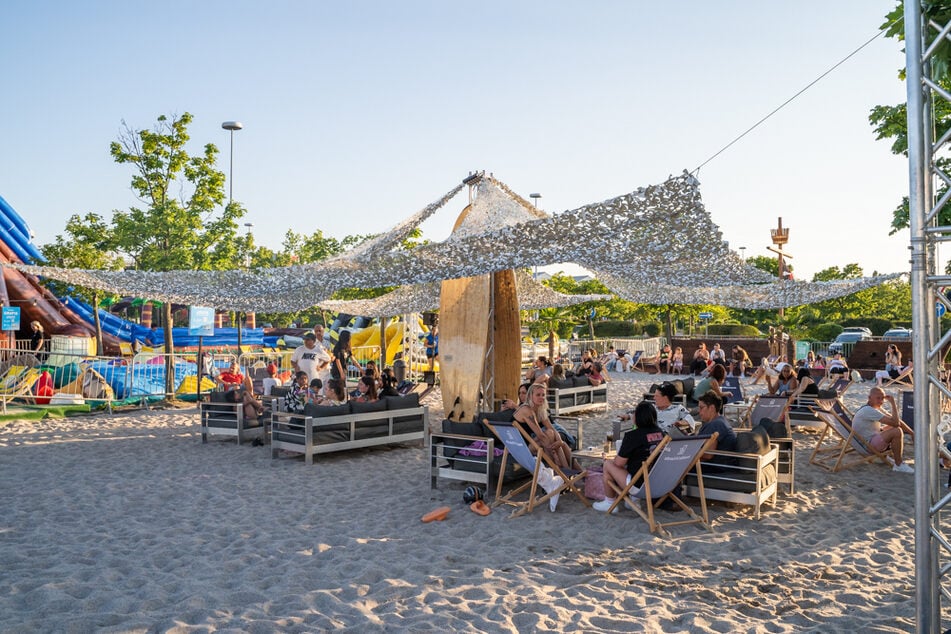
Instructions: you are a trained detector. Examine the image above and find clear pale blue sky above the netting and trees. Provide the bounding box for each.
[0,0,909,279]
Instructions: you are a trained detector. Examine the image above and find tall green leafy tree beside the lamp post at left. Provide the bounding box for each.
[109,112,245,393]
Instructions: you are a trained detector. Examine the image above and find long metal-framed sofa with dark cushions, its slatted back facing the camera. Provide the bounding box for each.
[271,394,429,464]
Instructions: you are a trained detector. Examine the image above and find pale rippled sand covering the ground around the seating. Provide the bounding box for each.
[0,373,914,632]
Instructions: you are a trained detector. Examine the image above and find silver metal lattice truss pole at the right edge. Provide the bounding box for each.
[904,0,951,632]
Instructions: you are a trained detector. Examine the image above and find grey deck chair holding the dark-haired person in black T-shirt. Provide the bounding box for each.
[608,433,717,537]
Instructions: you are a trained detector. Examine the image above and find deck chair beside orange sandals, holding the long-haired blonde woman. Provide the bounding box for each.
[482,420,591,517]
